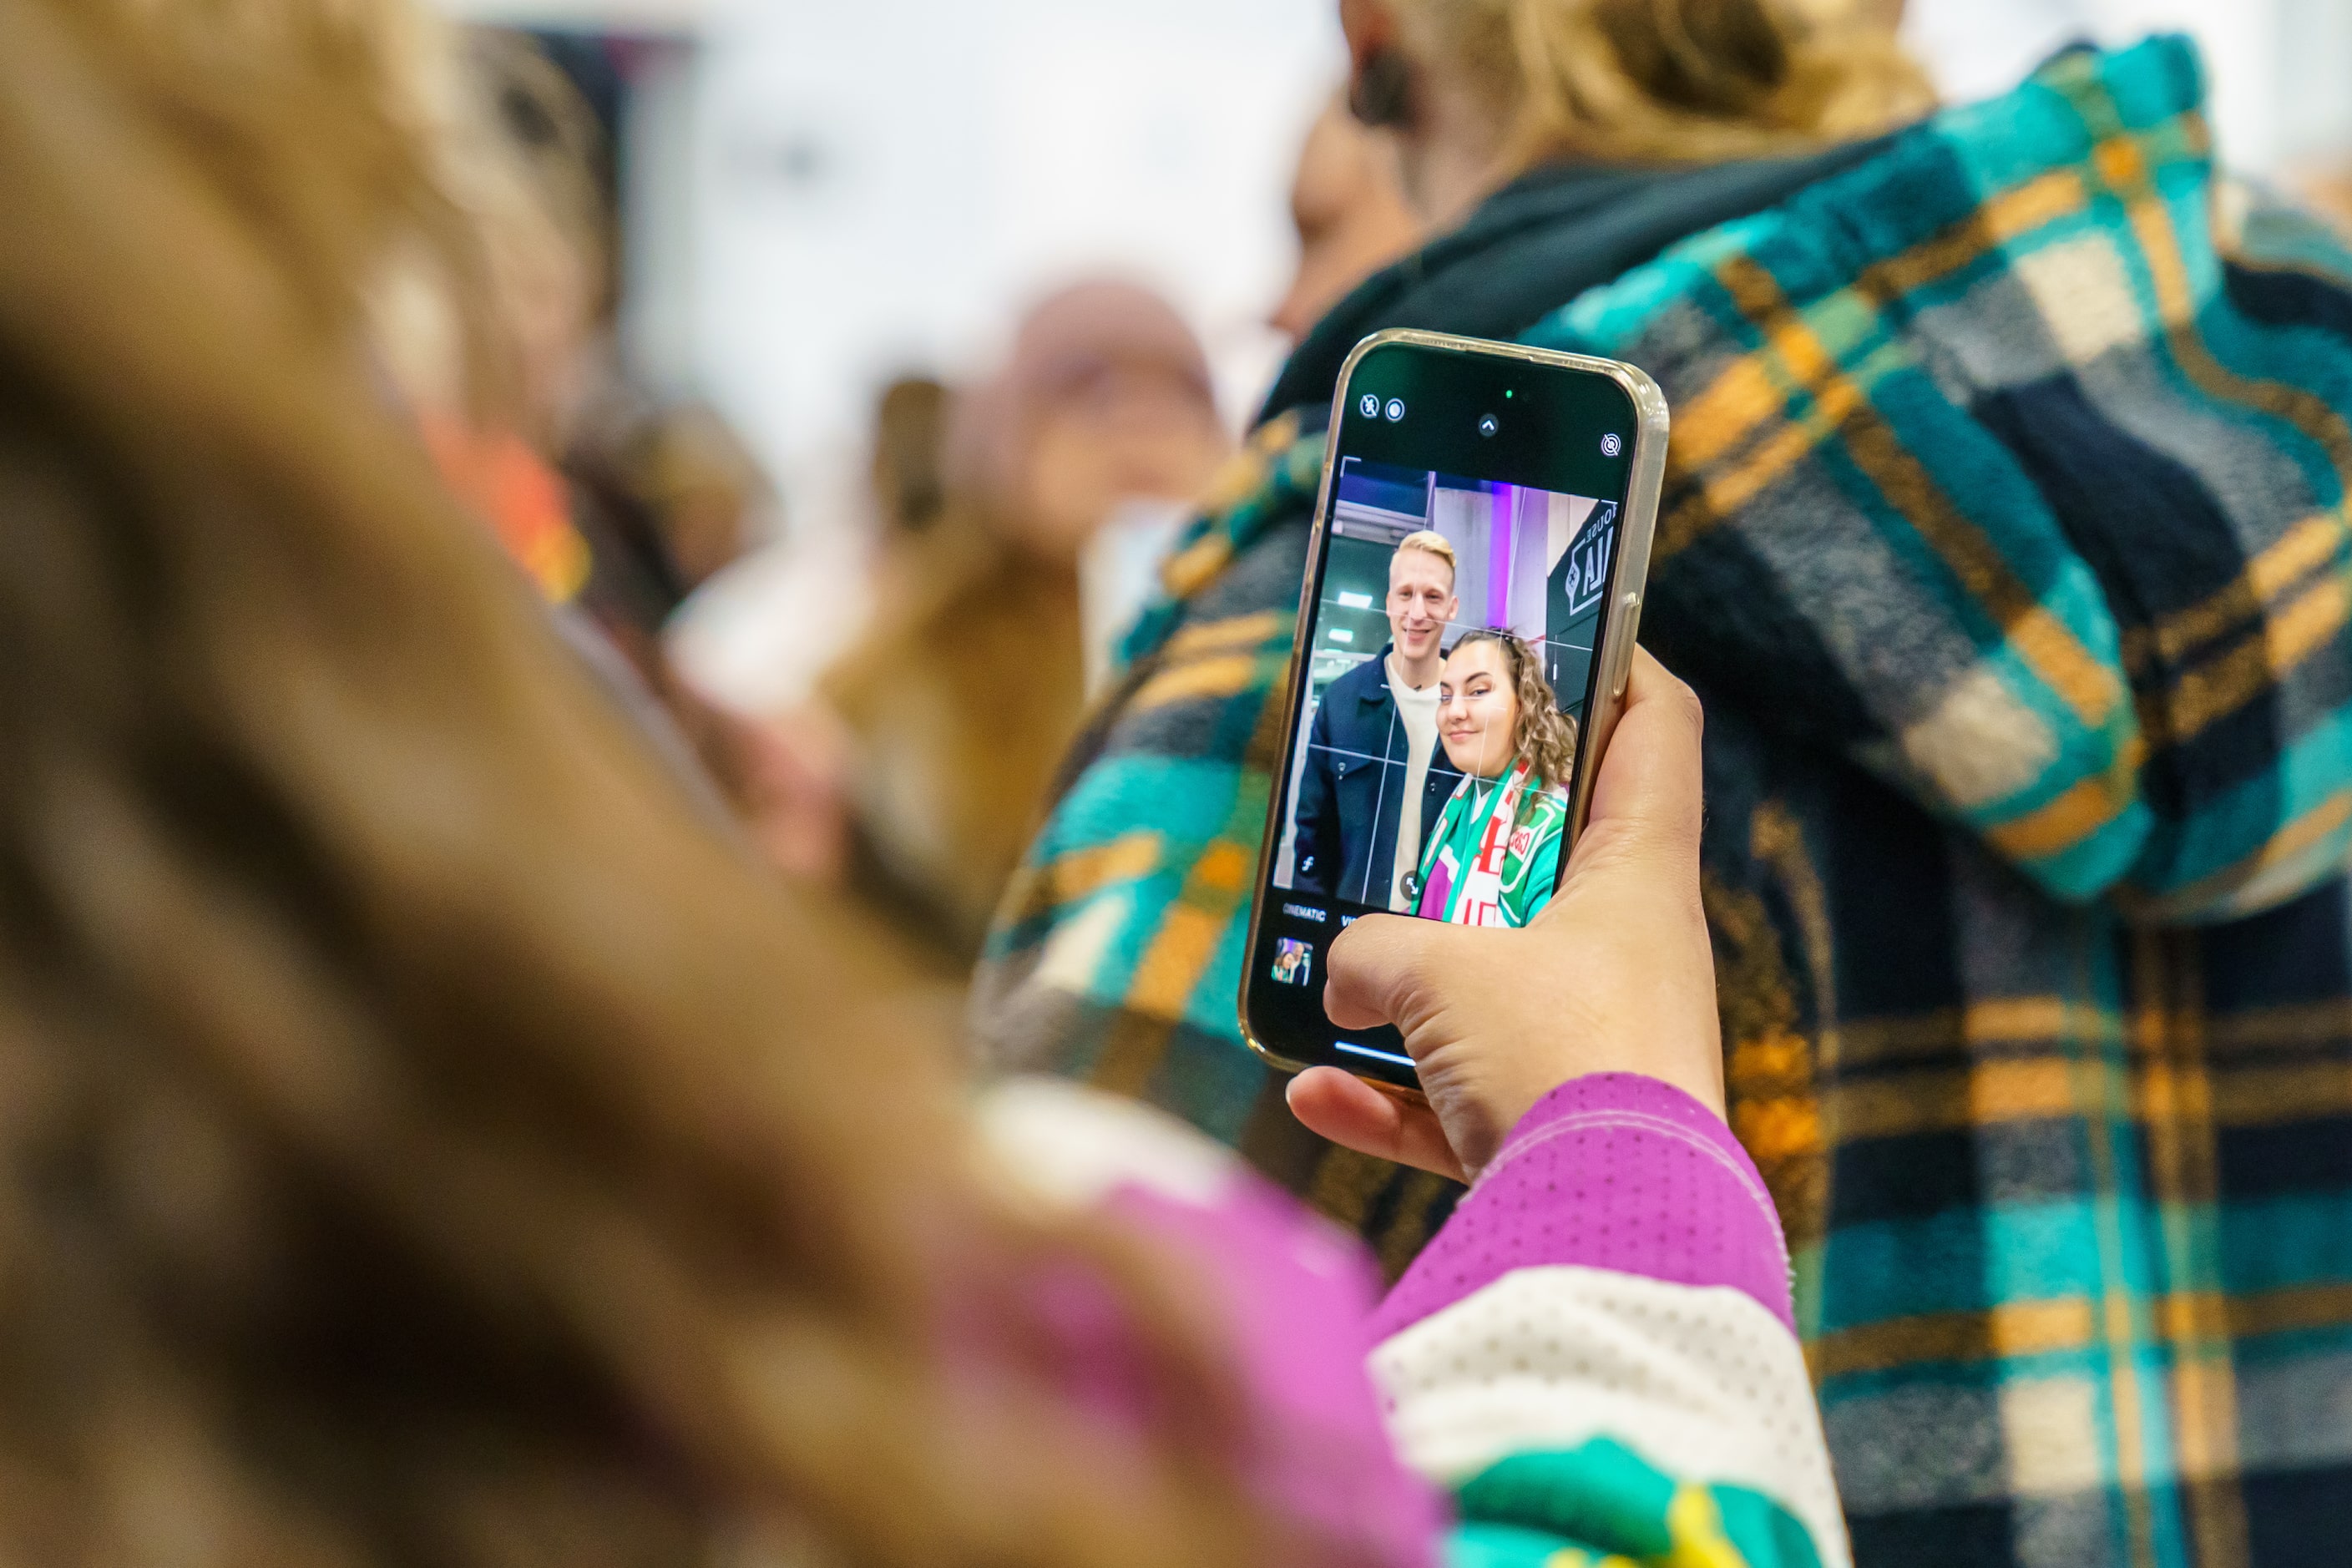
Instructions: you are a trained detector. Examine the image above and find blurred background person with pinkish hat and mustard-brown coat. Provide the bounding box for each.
[821,282,1227,959]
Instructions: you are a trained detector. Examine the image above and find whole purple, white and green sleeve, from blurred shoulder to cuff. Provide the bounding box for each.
[984,1075,1846,1568]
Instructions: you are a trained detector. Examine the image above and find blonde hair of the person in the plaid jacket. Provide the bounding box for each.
[1388,0,1935,167]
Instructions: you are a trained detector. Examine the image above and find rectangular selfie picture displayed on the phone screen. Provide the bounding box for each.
[1272,463,1618,930]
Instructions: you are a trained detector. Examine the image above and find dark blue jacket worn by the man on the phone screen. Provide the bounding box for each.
[1292,644,1463,910]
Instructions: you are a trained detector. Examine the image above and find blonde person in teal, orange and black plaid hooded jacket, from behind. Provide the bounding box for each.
[979,0,2352,1568]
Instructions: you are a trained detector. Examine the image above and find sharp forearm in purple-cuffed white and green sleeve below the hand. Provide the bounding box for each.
[1371,1075,1846,1563]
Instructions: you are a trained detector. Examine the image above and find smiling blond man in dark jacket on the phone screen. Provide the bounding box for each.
[1292,529,1460,912]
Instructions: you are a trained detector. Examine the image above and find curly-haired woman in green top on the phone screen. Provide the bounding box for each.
[1414,630,1576,926]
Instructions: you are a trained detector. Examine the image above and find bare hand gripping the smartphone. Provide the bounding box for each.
[1289,651,1724,1180]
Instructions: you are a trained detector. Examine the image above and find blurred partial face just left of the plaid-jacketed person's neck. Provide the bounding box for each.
[1267,96,1423,341]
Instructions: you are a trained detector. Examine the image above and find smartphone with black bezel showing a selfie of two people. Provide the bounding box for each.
[1240,331,1667,1093]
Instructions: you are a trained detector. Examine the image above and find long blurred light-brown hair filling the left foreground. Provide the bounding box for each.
[0,0,1329,1568]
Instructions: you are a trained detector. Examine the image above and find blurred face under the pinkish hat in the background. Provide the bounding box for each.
[1014,367,1226,559]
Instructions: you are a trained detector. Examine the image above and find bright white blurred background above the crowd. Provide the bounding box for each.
[437,0,2352,557]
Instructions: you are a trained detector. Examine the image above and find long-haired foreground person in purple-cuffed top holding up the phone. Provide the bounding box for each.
[0,0,1844,1568]
